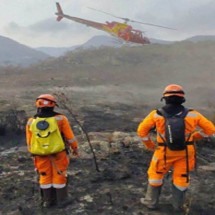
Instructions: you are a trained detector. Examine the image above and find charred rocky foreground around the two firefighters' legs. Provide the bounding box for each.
[0,123,215,215]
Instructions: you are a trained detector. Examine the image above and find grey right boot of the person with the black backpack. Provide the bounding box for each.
[172,185,186,213]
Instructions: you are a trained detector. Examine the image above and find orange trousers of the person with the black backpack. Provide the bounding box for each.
[148,147,195,190]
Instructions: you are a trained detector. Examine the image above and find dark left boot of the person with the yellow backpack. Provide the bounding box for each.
[41,187,56,208]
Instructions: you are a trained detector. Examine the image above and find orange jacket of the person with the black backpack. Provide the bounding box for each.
[137,110,215,152]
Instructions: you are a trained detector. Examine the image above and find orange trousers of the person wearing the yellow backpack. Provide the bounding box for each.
[34,151,69,188]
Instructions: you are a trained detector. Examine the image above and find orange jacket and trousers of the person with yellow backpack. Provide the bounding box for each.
[26,114,78,188]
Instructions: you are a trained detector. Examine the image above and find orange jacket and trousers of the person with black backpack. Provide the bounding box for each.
[137,110,215,190]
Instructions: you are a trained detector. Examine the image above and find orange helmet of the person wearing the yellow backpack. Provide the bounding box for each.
[36,94,58,108]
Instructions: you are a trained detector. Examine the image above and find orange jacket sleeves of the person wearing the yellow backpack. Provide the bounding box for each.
[26,114,78,150]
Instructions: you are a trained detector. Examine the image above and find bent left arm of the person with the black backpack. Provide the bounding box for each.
[137,111,156,151]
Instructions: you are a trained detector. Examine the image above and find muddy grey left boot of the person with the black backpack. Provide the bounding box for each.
[140,184,161,210]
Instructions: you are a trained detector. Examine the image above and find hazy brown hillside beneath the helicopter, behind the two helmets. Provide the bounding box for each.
[1,41,215,115]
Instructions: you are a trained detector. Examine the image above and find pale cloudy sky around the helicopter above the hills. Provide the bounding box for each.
[0,0,215,48]
